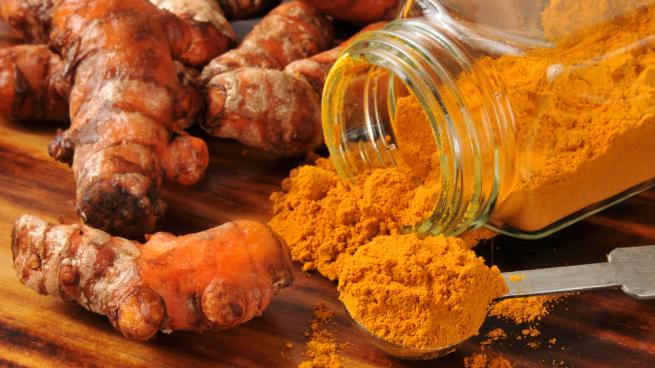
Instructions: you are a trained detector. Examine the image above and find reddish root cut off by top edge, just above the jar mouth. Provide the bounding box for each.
[302,0,400,24]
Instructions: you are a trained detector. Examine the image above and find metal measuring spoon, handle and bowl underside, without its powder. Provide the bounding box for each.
[346,245,655,360]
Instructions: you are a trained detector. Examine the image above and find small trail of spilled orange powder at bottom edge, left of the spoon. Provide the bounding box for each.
[298,303,343,368]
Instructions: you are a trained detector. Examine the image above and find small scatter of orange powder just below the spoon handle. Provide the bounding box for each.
[489,295,566,323]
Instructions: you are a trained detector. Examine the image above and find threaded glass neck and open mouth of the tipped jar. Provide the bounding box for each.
[322,18,515,235]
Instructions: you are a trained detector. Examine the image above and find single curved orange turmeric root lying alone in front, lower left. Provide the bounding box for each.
[12,215,293,340]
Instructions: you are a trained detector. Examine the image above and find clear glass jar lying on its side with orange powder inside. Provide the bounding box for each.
[322,0,655,238]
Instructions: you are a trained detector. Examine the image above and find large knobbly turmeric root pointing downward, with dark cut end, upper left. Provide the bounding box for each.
[0,0,209,237]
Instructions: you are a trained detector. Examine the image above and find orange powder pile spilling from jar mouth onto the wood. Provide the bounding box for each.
[270,96,493,280]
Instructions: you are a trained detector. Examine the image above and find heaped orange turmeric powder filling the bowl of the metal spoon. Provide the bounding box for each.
[339,234,507,348]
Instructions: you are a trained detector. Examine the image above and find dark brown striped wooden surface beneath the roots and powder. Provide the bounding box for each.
[0,121,655,367]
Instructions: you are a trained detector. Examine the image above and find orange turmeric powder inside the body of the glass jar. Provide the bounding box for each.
[490,0,655,231]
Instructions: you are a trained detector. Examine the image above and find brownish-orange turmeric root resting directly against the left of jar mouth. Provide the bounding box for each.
[201,23,384,156]
